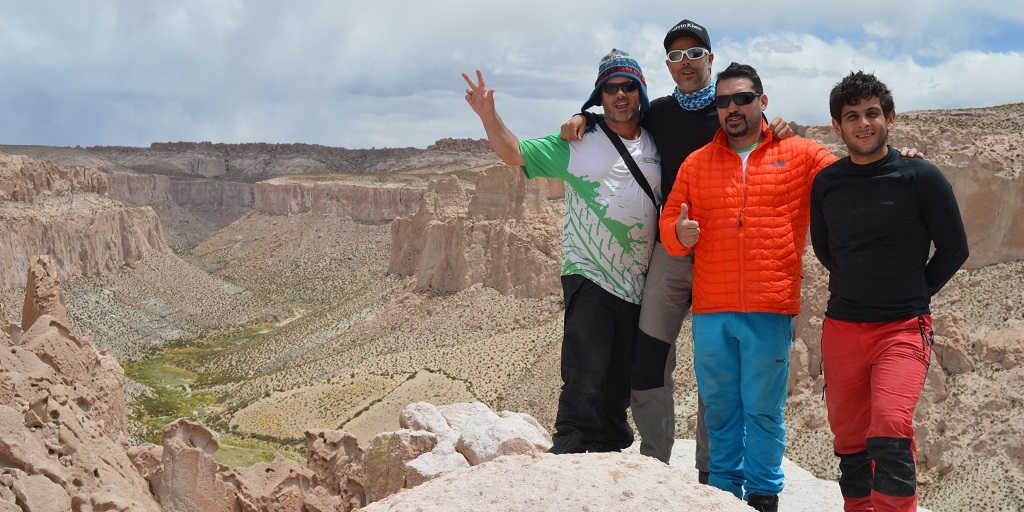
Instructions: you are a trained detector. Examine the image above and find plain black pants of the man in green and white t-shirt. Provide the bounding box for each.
[550,275,640,454]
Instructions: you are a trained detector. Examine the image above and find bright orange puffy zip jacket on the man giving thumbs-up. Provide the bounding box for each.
[658,121,838,314]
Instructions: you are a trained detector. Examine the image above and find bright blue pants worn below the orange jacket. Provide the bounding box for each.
[693,312,793,499]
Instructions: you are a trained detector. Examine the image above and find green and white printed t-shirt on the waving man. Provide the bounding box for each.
[519,130,663,304]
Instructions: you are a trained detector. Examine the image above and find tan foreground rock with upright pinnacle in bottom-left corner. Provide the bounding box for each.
[0,263,160,511]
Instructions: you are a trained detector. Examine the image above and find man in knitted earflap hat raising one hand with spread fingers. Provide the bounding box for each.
[463,50,662,454]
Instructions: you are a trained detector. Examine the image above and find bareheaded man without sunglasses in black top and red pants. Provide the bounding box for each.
[811,72,969,511]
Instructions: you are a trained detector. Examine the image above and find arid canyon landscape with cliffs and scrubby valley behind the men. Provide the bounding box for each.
[0,103,1024,512]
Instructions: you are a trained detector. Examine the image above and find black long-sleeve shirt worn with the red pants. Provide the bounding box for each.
[811,147,969,322]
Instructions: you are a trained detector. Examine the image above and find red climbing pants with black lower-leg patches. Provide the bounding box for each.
[821,314,932,512]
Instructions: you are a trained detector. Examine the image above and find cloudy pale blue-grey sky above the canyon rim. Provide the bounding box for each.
[0,0,1024,148]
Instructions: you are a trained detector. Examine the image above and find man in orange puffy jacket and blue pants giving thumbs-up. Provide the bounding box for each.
[660,62,836,511]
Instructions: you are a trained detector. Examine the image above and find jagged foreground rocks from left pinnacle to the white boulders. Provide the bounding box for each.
[0,257,565,512]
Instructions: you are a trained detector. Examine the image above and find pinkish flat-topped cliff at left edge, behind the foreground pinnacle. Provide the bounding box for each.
[0,154,170,290]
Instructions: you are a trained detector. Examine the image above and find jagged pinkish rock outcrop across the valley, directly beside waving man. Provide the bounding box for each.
[388,165,563,298]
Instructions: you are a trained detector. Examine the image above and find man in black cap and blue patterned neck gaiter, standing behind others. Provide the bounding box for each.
[561,19,793,483]
